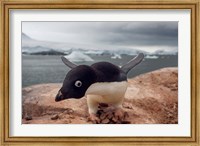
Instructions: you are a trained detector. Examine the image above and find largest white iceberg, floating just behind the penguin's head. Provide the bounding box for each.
[65,51,94,62]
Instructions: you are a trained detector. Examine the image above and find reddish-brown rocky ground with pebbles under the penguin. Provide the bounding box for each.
[22,68,178,124]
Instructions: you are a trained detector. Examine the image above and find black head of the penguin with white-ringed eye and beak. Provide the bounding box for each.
[55,65,96,101]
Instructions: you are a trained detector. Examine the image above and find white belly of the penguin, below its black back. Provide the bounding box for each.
[86,81,128,104]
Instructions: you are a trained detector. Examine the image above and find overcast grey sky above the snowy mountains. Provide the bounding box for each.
[22,21,178,51]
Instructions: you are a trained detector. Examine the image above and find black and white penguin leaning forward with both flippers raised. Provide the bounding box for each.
[55,53,144,120]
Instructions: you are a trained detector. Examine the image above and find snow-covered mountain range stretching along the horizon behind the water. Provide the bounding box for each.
[21,33,177,58]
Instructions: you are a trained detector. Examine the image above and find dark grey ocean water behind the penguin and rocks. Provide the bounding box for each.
[22,55,178,87]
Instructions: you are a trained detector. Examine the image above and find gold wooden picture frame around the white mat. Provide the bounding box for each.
[0,0,200,145]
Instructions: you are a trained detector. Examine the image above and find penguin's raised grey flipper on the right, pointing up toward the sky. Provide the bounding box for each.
[121,53,144,74]
